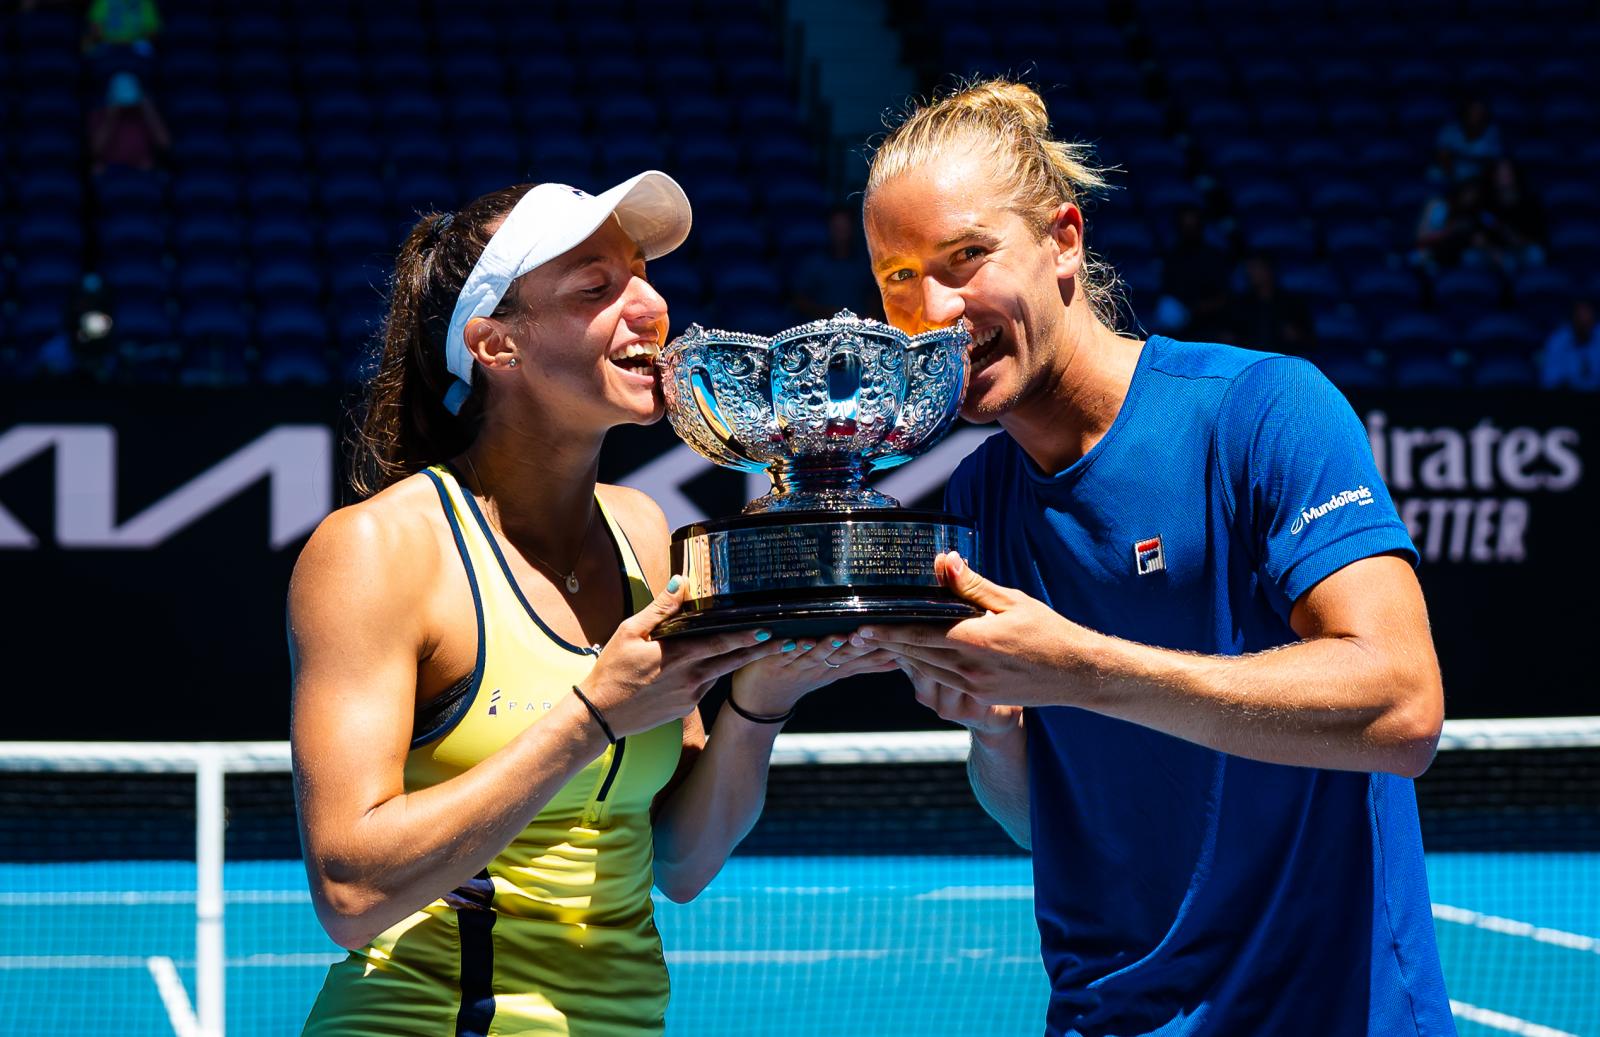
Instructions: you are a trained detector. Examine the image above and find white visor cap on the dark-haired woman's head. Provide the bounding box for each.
[445,170,691,414]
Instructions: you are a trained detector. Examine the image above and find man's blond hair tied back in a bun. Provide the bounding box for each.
[866,78,1118,328]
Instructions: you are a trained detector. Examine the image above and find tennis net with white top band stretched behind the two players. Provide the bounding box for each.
[0,717,1600,1037]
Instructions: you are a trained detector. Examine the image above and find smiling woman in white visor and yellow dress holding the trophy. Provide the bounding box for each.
[290,171,893,1037]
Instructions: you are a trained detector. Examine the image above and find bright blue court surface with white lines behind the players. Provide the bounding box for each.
[0,853,1600,1037]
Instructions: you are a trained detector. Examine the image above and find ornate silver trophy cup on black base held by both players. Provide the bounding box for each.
[656,310,981,637]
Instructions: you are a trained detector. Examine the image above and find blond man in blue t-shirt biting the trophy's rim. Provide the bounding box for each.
[859,82,1454,1037]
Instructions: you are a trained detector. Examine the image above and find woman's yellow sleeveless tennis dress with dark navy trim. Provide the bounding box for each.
[304,466,683,1037]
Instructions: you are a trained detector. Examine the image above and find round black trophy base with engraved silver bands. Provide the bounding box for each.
[654,507,982,639]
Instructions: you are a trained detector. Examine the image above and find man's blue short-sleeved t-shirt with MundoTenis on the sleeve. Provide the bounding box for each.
[946,336,1456,1037]
